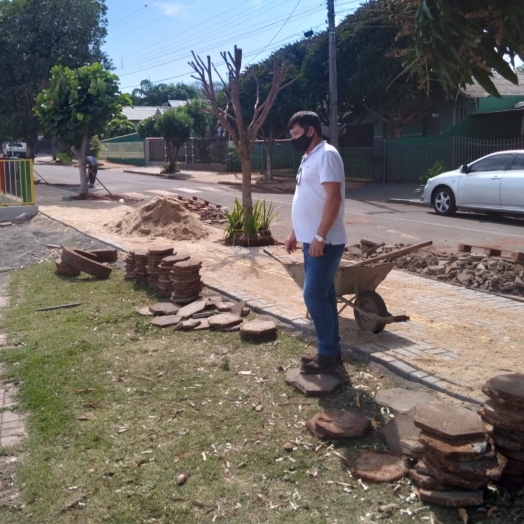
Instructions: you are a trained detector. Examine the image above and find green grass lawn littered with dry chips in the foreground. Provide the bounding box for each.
[0,264,517,524]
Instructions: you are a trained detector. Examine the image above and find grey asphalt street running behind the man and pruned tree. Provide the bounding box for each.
[35,164,524,251]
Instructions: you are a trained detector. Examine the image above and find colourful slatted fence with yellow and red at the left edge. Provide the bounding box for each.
[0,159,35,206]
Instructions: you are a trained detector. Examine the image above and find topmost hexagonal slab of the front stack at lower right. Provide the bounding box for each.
[415,402,484,442]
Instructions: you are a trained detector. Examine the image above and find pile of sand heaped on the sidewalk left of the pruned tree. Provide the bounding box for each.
[109,197,208,240]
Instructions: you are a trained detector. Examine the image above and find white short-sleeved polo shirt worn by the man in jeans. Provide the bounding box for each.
[291,142,347,244]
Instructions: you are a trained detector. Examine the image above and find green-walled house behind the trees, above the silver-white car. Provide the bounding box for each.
[340,73,524,147]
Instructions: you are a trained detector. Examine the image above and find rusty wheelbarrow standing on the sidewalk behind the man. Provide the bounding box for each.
[264,249,409,333]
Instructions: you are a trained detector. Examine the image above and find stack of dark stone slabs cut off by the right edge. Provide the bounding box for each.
[479,373,524,489]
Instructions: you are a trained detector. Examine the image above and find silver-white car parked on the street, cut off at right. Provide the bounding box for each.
[423,150,524,215]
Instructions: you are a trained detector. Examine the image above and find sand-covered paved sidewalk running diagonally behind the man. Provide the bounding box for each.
[27,196,524,403]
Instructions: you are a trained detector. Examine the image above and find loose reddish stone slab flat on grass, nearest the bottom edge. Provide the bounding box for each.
[348,450,409,482]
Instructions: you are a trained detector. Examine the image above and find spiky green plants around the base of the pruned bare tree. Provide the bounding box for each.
[224,198,277,245]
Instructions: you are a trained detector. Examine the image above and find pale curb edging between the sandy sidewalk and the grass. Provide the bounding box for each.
[33,212,483,406]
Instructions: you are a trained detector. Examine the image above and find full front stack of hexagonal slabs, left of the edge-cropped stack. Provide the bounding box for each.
[409,402,507,507]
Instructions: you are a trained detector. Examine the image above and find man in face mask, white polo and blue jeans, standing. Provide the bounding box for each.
[286,111,347,373]
